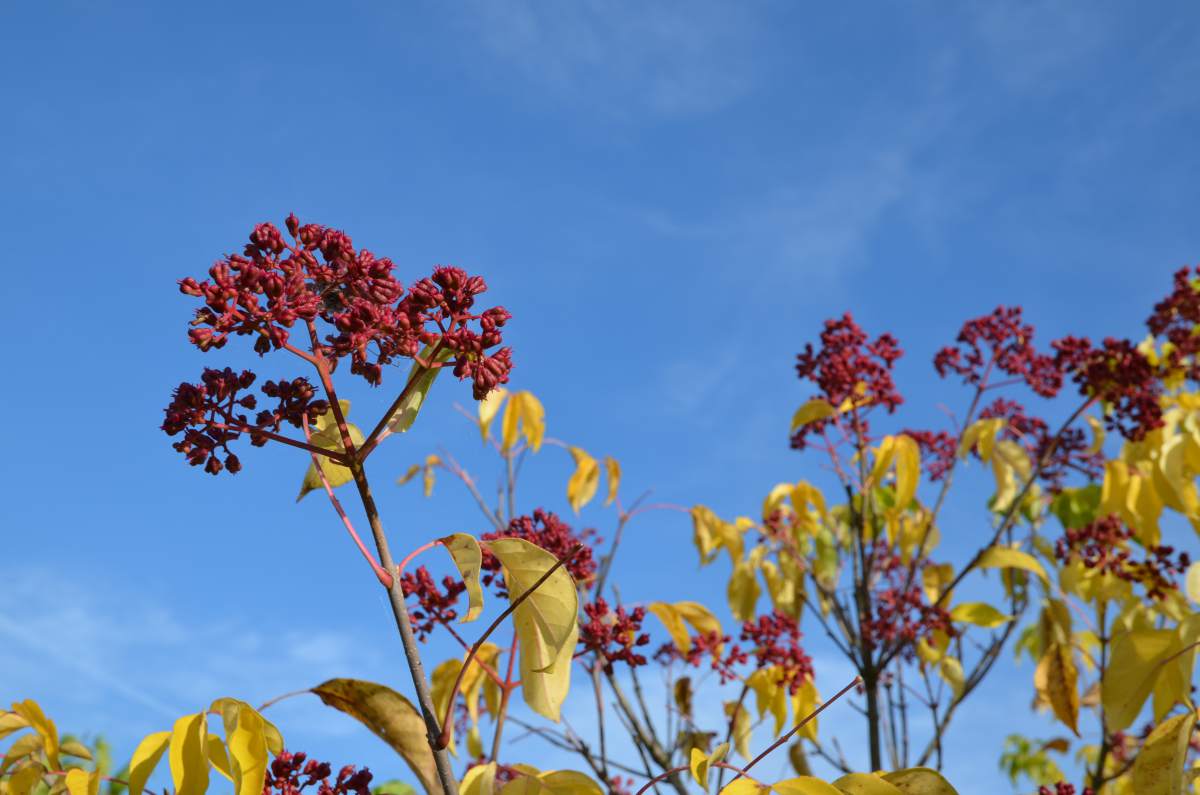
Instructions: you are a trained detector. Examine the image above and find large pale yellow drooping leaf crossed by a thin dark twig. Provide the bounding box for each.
[487,538,578,721]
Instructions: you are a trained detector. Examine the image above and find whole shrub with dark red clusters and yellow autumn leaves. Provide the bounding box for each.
[0,216,1200,795]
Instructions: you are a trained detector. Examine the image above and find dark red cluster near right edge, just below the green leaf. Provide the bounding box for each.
[1054,514,1192,599]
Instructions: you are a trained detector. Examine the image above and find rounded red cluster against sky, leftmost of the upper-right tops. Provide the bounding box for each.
[792,312,904,450]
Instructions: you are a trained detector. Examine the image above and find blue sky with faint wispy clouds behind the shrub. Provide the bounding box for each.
[0,0,1200,793]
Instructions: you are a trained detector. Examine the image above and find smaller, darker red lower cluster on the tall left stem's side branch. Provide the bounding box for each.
[161,367,329,474]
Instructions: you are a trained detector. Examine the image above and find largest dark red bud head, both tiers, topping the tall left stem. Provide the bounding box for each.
[162,215,512,474]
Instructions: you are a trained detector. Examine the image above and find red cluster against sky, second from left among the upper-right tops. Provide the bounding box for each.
[934,306,1062,398]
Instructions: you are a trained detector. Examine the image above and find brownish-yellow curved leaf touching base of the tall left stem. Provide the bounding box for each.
[312,679,444,795]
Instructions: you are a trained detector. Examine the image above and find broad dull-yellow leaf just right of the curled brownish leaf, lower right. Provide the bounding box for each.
[1100,629,1178,731]
